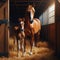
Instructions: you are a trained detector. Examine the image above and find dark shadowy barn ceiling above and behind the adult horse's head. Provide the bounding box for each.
[10,0,53,22]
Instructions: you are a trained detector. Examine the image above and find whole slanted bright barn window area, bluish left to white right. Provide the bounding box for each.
[39,3,55,25]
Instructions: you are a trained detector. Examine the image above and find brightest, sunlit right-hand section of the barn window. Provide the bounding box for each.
[48,4,55,24]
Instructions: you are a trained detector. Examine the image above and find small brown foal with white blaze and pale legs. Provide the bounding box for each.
[14,18,25,56]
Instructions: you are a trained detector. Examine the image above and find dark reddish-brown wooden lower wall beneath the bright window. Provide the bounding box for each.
[41,23,56,49]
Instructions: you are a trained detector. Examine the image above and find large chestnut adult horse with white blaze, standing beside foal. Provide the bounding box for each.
[25,5,41,54]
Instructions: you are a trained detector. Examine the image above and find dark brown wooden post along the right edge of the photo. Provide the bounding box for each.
[55,0,60,56]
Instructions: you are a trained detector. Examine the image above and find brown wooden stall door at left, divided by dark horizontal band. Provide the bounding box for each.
[0,2,8,56]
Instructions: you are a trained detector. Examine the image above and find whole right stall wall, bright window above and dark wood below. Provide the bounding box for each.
[40,1,56,50]
